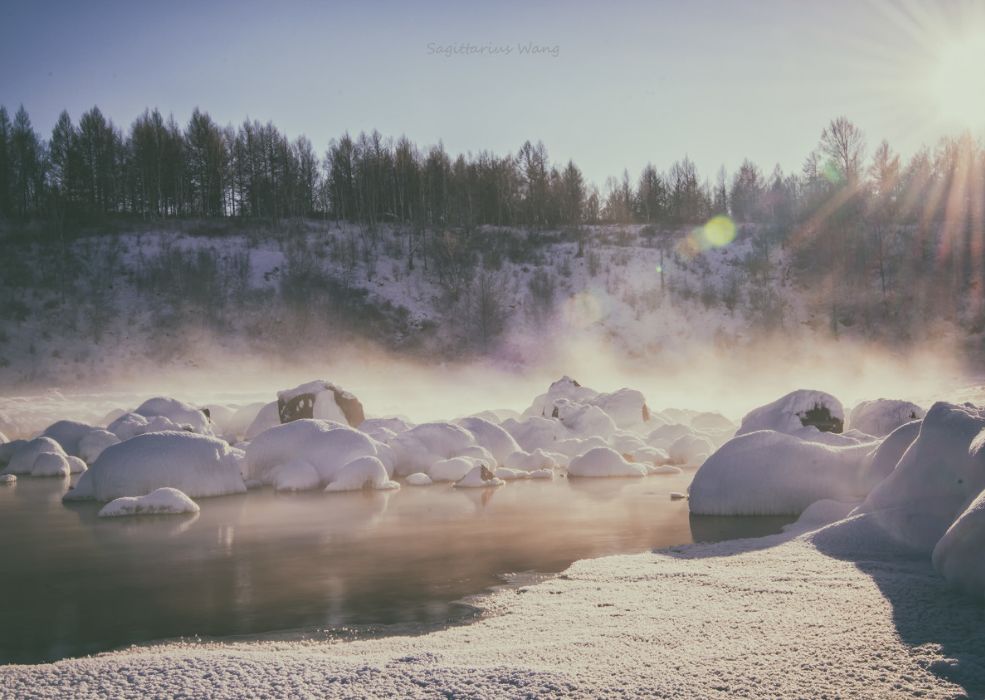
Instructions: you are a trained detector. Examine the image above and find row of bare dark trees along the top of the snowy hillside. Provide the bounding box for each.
[0,106,985,241]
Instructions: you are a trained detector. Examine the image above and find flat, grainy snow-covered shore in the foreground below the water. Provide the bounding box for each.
[0,520,985,697]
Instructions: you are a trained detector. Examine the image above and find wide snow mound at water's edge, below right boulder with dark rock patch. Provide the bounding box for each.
[690,430,871,515]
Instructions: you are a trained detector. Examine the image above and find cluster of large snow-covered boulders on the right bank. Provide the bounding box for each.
[690,391,985,599]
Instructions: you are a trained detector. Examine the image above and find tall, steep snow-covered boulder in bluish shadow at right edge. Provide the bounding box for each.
[856,402,985,553]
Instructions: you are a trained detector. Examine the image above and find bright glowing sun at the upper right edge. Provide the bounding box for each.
[932,33,985,129]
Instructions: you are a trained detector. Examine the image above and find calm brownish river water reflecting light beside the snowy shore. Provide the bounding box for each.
[0,474,778,663]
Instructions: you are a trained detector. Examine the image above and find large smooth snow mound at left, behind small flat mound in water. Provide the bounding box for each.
[64,431,246,501]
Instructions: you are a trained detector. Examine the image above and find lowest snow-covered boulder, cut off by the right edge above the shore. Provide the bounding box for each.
[933,492,985,601]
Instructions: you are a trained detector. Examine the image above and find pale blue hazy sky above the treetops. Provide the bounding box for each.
[0,0,985,186]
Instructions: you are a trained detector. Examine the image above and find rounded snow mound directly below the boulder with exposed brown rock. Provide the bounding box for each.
[244,418,380,485]
